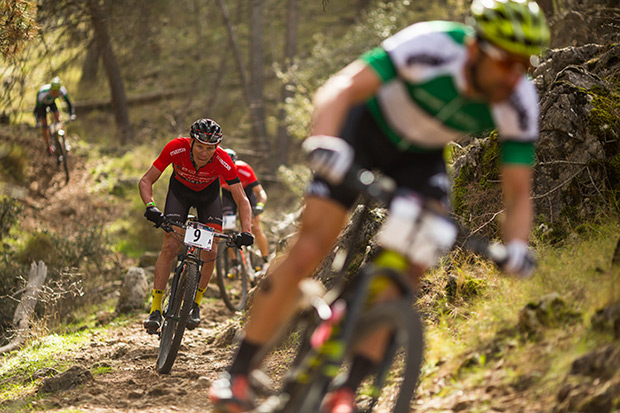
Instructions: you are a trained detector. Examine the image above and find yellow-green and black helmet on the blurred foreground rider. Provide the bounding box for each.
[471,0,550,56]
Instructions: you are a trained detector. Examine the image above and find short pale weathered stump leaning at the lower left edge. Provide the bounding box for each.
[0,261,47,354]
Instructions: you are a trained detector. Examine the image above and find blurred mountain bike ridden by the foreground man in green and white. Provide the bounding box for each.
[251,170,507,413]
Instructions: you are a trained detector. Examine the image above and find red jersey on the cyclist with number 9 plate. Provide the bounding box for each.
[153,137,240,191]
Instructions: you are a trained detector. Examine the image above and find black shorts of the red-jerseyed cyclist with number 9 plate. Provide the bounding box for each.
[164,174,222,231]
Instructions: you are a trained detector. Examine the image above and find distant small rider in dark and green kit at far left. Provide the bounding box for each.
[33,76,75,155]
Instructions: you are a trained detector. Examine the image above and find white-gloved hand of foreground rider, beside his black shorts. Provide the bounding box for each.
[302,135,354,185]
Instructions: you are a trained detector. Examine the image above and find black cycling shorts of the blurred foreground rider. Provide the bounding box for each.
[307,105,449,209]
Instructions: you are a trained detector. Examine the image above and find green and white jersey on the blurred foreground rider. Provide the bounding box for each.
[361,21,538,164]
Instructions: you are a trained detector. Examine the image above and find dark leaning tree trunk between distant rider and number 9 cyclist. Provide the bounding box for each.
[87,0,133,144]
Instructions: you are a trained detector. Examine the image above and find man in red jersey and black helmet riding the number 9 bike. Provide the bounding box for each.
[139,118,254,330]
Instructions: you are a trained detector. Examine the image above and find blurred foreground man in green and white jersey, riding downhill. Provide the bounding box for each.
[209,0,549,412]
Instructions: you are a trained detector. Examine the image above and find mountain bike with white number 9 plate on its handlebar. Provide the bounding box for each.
[148,216,235,374]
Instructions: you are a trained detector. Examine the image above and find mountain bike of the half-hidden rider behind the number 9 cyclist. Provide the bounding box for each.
[215,214,262,311]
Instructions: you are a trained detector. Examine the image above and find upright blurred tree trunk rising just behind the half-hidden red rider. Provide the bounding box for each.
[249,0,273,156]
